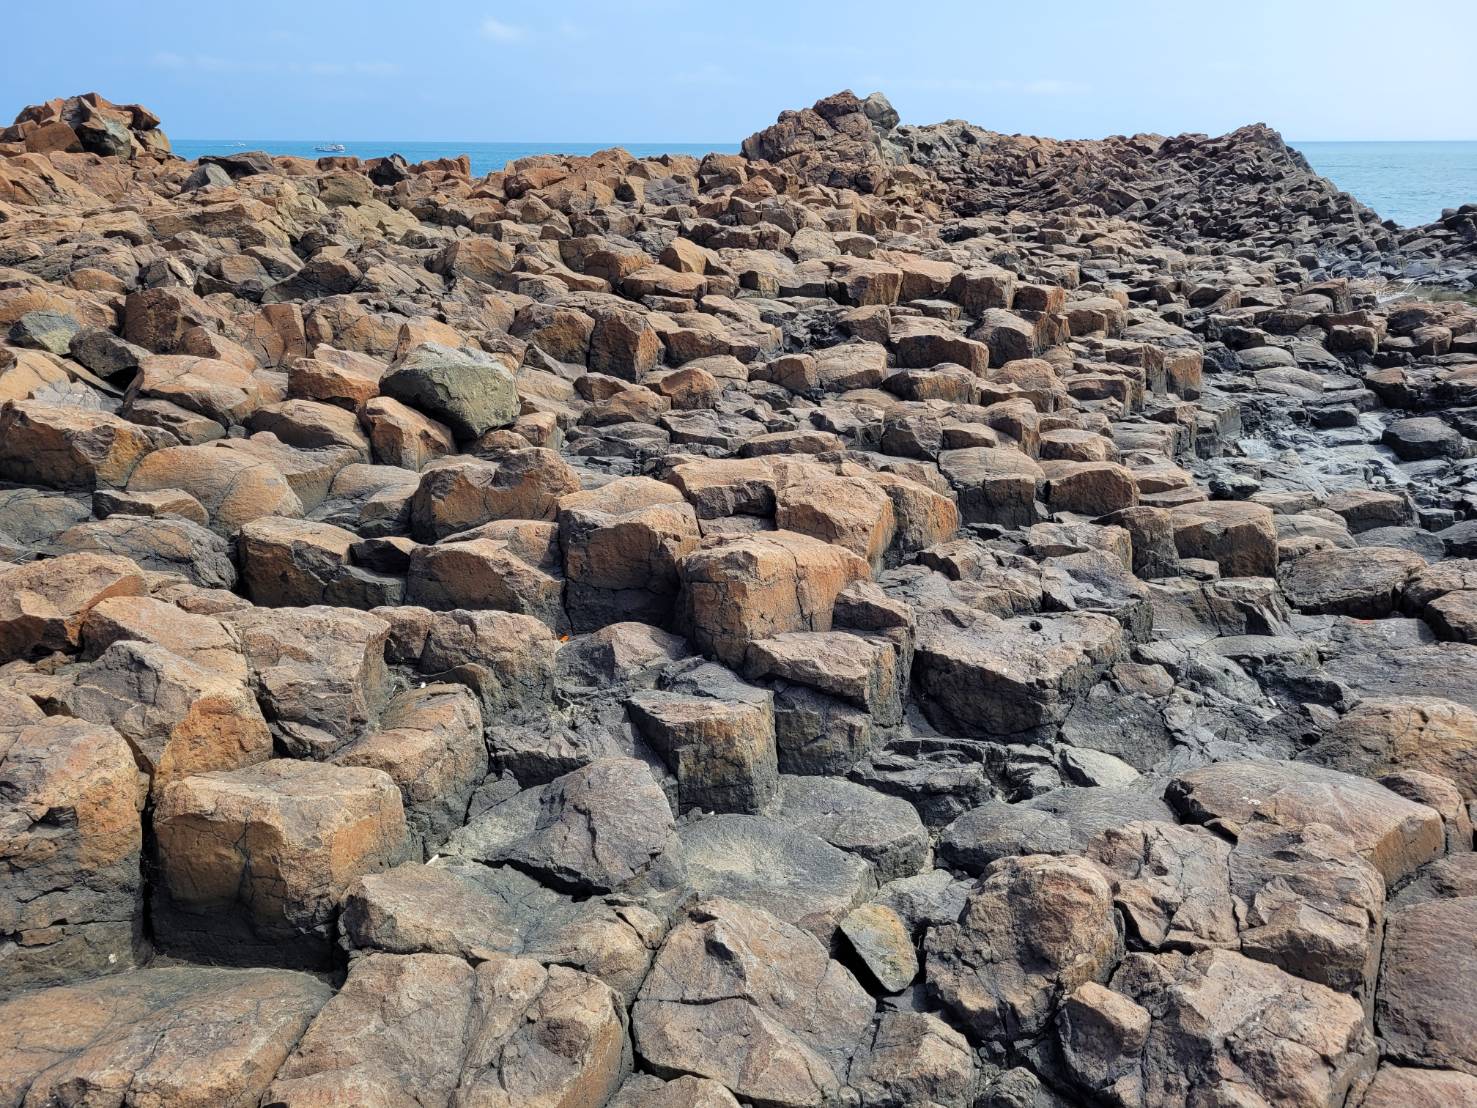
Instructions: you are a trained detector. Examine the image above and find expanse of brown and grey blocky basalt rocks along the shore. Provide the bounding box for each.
[0,93,1477,1108]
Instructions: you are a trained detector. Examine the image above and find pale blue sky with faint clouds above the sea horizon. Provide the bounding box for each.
[0,0,1477,142]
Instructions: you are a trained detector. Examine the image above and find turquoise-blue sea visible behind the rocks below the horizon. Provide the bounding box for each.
[171,139,1477,228]
